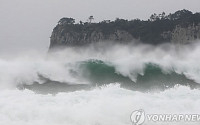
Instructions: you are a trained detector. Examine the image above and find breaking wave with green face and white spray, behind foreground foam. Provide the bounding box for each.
[0,43,200,92]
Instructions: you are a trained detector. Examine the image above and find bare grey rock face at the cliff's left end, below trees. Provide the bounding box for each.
[50,25,134,48]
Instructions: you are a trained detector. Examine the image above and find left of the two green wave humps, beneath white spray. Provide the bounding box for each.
[79,60,133,84]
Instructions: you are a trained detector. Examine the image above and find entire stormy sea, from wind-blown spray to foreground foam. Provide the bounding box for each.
[0,42,200,125]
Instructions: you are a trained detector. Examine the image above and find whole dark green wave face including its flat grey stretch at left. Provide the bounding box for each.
[18,60,200,93]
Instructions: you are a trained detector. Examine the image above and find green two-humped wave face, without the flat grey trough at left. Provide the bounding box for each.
[79,60,199,91]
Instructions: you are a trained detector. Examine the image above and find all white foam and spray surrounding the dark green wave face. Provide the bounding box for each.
[0,41,200,125]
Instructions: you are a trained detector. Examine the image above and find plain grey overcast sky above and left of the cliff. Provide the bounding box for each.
[0,0,200,54]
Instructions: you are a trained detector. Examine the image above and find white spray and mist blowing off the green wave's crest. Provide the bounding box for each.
[0,42,200,87]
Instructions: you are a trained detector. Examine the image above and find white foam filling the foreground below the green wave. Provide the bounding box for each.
[0,84,200,125]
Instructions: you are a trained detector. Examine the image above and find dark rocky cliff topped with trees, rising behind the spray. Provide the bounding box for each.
[50,10,200,49]
